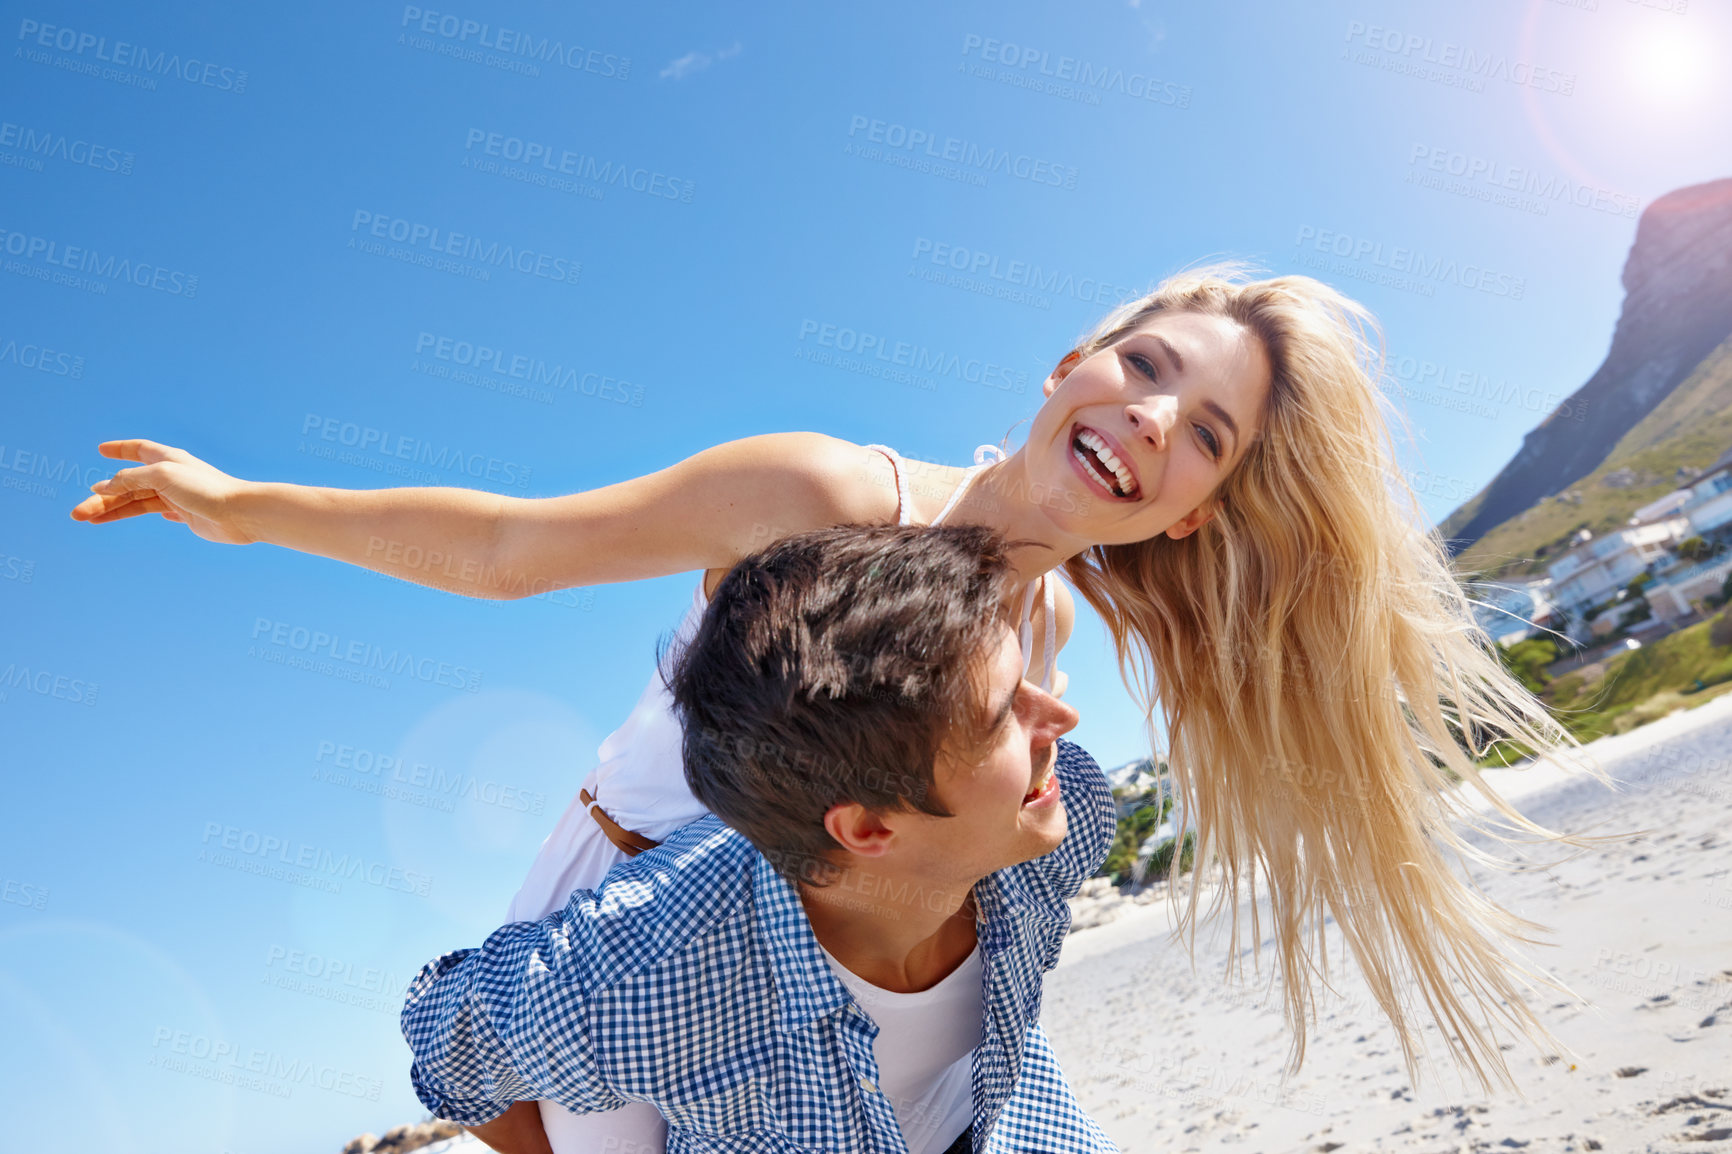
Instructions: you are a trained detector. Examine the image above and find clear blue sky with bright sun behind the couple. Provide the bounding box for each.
[0,0,1732,1154]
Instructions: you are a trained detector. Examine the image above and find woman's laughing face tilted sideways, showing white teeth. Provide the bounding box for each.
[1024,303,1271,544]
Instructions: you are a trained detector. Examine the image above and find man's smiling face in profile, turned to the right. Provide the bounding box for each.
[899,622,1077,884]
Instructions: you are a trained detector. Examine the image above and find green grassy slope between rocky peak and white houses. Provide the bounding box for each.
[1439,338,1732,579]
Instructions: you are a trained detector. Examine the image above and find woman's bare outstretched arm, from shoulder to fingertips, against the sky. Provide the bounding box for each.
[71,433,895,600]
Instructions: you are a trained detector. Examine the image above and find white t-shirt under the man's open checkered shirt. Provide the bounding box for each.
[819,944,986,1154]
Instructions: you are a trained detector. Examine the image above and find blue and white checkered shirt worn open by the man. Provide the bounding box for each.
[402,742,1117,1154]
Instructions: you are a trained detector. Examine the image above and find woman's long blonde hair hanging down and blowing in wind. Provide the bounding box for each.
[1065,262,1604,1088]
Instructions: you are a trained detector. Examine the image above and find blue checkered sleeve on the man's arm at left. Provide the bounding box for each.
[398,901,625,1126]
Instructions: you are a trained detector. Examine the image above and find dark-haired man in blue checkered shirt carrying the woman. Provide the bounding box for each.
[402,527,1114,1154]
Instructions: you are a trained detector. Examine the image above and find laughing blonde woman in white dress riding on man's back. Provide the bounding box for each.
[73,263,1600,1149]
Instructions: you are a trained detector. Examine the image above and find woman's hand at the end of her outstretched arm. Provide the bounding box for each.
[73,440,256,544]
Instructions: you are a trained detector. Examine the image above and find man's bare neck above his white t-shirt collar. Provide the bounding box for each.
[798,870,975,993]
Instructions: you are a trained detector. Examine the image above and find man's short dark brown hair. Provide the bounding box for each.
[665,525,1017,884]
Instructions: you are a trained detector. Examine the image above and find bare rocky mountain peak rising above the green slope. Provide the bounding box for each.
[1439,178,1732,553]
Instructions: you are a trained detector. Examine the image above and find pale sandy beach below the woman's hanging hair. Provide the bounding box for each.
[1041,697,1732,1154]
